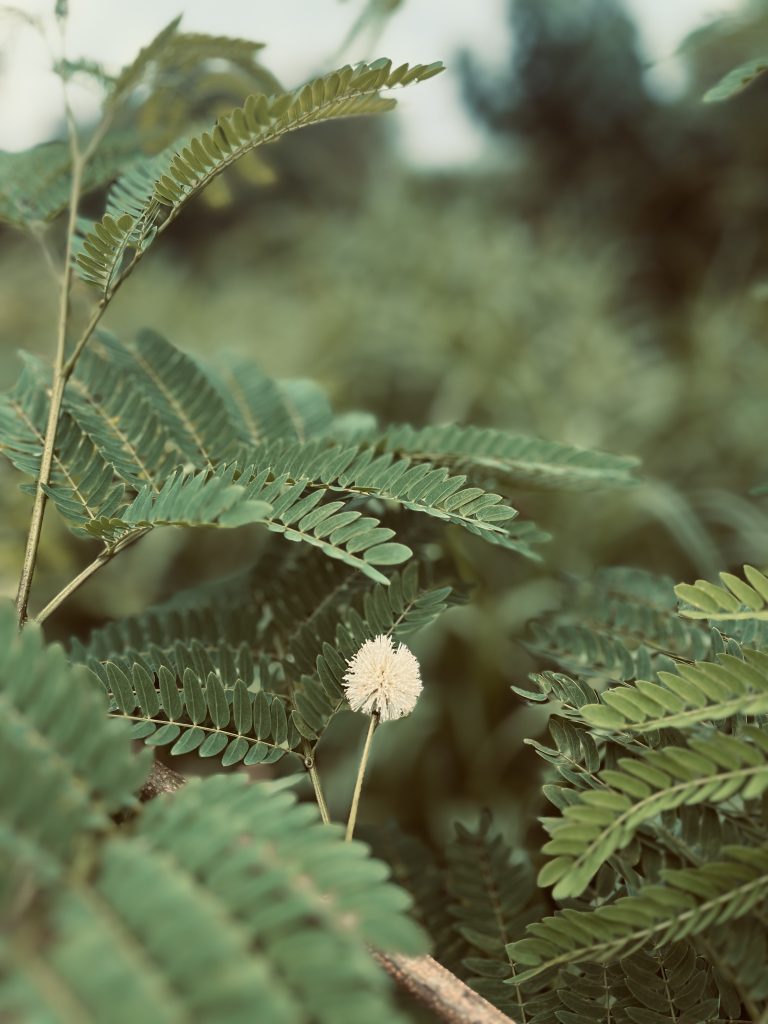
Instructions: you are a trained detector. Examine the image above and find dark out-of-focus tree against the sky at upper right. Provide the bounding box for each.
[464,0,768,311]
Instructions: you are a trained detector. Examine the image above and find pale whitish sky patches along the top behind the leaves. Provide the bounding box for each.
[0,0,739,166]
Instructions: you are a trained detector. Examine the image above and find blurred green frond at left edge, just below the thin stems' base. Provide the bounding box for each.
[0,601,147,888]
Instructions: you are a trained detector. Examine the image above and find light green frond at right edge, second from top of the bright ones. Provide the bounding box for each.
[581,650,768,733]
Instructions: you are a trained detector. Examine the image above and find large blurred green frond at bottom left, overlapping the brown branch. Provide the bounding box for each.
[0,776,424,1024]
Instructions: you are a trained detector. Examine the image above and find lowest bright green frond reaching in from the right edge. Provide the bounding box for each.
[508,846,768,984]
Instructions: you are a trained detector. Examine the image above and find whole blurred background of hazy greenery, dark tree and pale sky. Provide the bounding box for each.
[0,0,768,840]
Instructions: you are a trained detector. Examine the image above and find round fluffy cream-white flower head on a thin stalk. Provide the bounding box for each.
[344,635,422,722]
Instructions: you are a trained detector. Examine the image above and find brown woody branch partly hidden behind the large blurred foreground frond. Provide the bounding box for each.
[139,761,514,1024]
